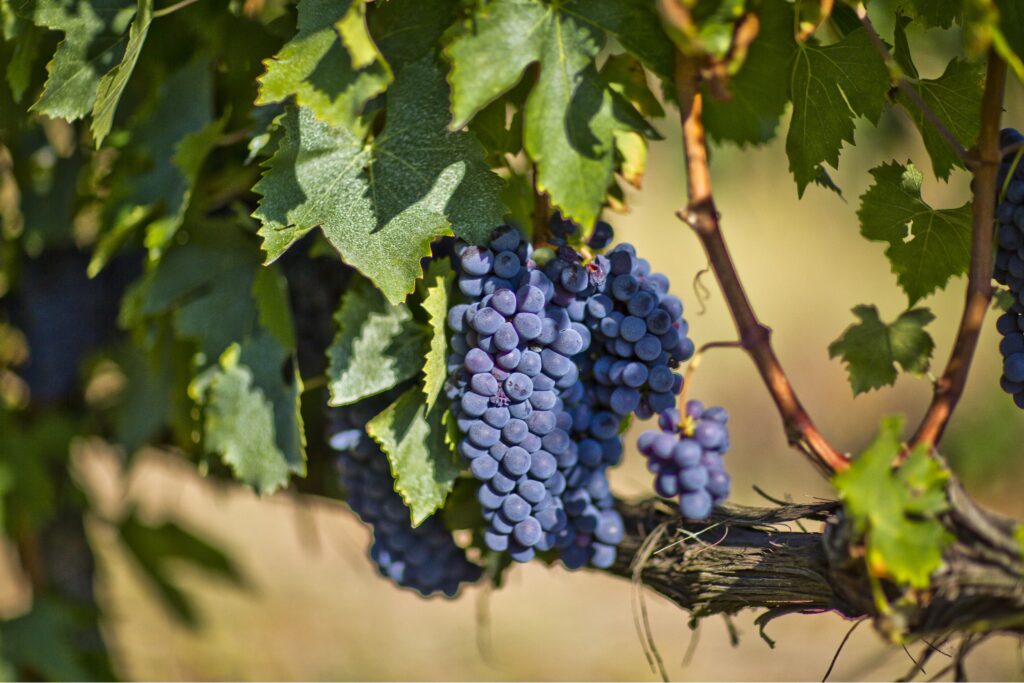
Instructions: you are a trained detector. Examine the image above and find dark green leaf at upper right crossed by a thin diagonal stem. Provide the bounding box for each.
[895,22,985,179]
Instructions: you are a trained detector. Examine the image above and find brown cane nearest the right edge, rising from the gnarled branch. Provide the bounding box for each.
[909,49,1007,450]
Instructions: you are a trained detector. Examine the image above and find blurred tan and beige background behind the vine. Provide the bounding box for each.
[0,18,1024,680]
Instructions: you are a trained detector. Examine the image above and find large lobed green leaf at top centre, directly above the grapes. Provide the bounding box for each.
[445,0,660,227]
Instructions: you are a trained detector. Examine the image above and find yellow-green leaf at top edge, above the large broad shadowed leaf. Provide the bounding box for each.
[256,0,392,127]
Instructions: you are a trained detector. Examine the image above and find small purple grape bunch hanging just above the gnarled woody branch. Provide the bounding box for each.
[637,400,729,519]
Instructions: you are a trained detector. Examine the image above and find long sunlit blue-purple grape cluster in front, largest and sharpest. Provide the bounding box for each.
[447,227,586,562]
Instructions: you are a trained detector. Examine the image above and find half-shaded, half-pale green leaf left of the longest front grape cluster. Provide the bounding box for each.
[327,280,427,405]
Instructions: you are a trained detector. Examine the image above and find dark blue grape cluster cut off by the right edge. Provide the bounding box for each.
[994,129,1024,409]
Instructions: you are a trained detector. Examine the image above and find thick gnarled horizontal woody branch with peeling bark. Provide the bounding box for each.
[608,491,1024,643]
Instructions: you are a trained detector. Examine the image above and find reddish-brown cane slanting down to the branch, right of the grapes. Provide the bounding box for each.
[675,52,849,477]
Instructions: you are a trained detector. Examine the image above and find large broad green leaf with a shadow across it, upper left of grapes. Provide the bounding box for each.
[254,57,505,303]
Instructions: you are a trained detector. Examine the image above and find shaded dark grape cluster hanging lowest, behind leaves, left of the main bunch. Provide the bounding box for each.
[329,407,482,597]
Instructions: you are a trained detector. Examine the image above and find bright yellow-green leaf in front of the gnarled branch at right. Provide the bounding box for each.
[833,417,952,589]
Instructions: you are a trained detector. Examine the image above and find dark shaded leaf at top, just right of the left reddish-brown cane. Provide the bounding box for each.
[703,0,797,144]
